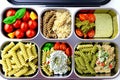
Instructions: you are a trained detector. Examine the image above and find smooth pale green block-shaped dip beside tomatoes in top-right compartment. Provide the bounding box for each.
[95,14,113,37]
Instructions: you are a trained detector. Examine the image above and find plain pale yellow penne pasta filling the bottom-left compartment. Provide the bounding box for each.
[0,42,38,77]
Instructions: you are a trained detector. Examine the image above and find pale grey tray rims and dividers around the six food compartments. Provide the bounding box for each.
[0,6,120,80]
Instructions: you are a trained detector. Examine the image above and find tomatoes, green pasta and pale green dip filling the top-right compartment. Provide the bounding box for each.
[75,10,118,39]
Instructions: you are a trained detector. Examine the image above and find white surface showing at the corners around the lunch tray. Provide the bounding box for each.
[0,0,120,80]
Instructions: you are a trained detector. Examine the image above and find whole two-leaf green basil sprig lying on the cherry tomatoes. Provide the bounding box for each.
[3,8,26,24]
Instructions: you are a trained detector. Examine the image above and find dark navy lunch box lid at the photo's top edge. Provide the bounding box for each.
[8,0,110,6]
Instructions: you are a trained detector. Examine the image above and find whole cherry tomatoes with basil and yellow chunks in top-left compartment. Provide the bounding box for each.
[2,8,38,39]
